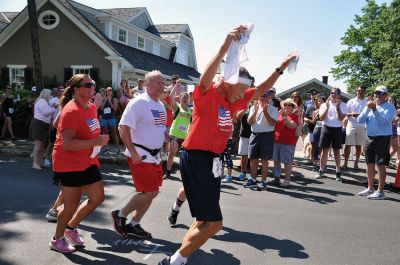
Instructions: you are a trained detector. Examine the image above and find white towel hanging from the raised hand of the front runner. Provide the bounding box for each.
[224,24,254,84]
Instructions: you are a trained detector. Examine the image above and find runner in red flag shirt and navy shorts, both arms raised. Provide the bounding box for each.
[159,26,294,265]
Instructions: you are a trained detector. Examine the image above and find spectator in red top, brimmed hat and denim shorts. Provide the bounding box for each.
[272,98,300,186]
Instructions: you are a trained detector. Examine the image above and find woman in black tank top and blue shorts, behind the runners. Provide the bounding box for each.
[100,87,121,155]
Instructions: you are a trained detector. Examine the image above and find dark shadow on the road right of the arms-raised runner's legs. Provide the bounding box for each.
[213,226,309,259]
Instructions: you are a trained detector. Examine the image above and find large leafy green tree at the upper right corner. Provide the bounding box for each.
[331,0,400,96]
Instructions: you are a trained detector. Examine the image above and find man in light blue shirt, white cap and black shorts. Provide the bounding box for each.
[357,86,396,200]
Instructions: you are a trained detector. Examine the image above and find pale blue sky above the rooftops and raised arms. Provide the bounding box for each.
[0,0,388,93]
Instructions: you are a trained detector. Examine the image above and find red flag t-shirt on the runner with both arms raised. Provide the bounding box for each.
[182,84,254,154]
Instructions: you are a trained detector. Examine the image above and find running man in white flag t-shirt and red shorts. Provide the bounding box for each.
[111,71,176,239]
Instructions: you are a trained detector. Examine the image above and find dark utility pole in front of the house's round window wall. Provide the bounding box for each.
[28,0,43,94]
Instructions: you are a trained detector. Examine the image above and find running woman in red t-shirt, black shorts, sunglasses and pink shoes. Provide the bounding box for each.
[49,74,109,252]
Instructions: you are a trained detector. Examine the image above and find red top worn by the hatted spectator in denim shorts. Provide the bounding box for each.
[274,113,300,145]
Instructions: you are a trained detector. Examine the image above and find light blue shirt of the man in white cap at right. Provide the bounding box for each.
[357,102,396,136]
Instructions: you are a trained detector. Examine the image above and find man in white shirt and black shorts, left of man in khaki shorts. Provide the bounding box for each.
[315,88,347,181]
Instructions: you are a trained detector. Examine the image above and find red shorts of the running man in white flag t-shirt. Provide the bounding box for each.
[128,157,163,192]
